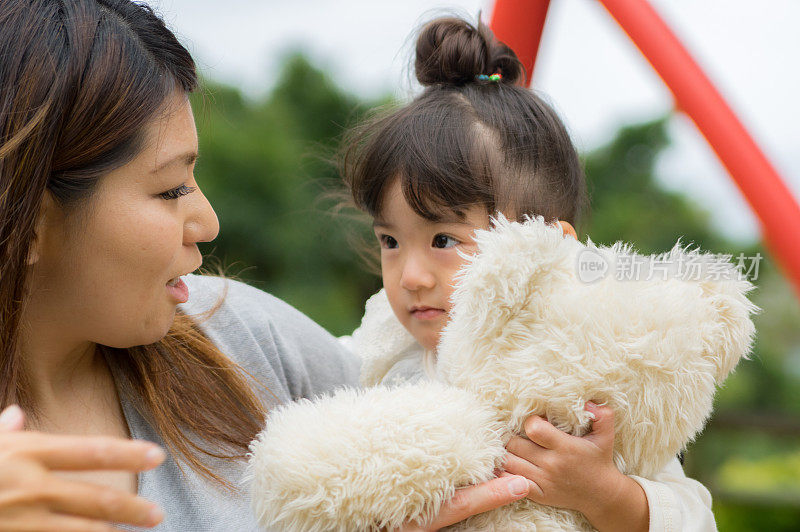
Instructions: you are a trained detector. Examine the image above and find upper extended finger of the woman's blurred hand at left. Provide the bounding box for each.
[18,433,166,472]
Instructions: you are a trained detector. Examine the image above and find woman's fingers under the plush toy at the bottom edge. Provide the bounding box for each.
[400,473,528,532]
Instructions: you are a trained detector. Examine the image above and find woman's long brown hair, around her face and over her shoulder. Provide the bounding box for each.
[0,0,264,486]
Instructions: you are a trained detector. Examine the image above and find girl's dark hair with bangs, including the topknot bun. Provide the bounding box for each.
[341,17,586,225]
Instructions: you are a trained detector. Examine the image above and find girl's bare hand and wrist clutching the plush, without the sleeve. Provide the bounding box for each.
[504,402,649,531]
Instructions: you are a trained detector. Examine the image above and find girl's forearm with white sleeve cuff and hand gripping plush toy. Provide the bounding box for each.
[506,403,716,532]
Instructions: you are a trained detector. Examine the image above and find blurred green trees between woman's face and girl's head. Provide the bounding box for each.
[193,55,379,334]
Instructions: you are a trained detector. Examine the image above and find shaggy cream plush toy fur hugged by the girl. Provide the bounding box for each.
[250,217,757,532]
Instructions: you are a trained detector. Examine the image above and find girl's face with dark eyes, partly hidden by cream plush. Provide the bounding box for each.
[374,180,489,350]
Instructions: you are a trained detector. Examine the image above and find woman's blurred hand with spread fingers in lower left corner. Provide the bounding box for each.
[0,406,165,532]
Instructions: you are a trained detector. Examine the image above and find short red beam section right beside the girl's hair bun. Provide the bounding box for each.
[490,0,550,87]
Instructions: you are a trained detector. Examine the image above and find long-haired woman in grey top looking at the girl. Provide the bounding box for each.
[0,0,528,531]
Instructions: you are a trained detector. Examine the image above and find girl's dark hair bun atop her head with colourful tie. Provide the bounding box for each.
[414,17,524,86]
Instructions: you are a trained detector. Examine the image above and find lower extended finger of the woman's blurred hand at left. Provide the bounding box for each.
[43,479,164,527]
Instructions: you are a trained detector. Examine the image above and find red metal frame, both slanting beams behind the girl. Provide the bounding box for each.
[491,0,800,296]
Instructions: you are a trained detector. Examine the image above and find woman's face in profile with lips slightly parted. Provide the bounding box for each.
[29,93,219,347]
